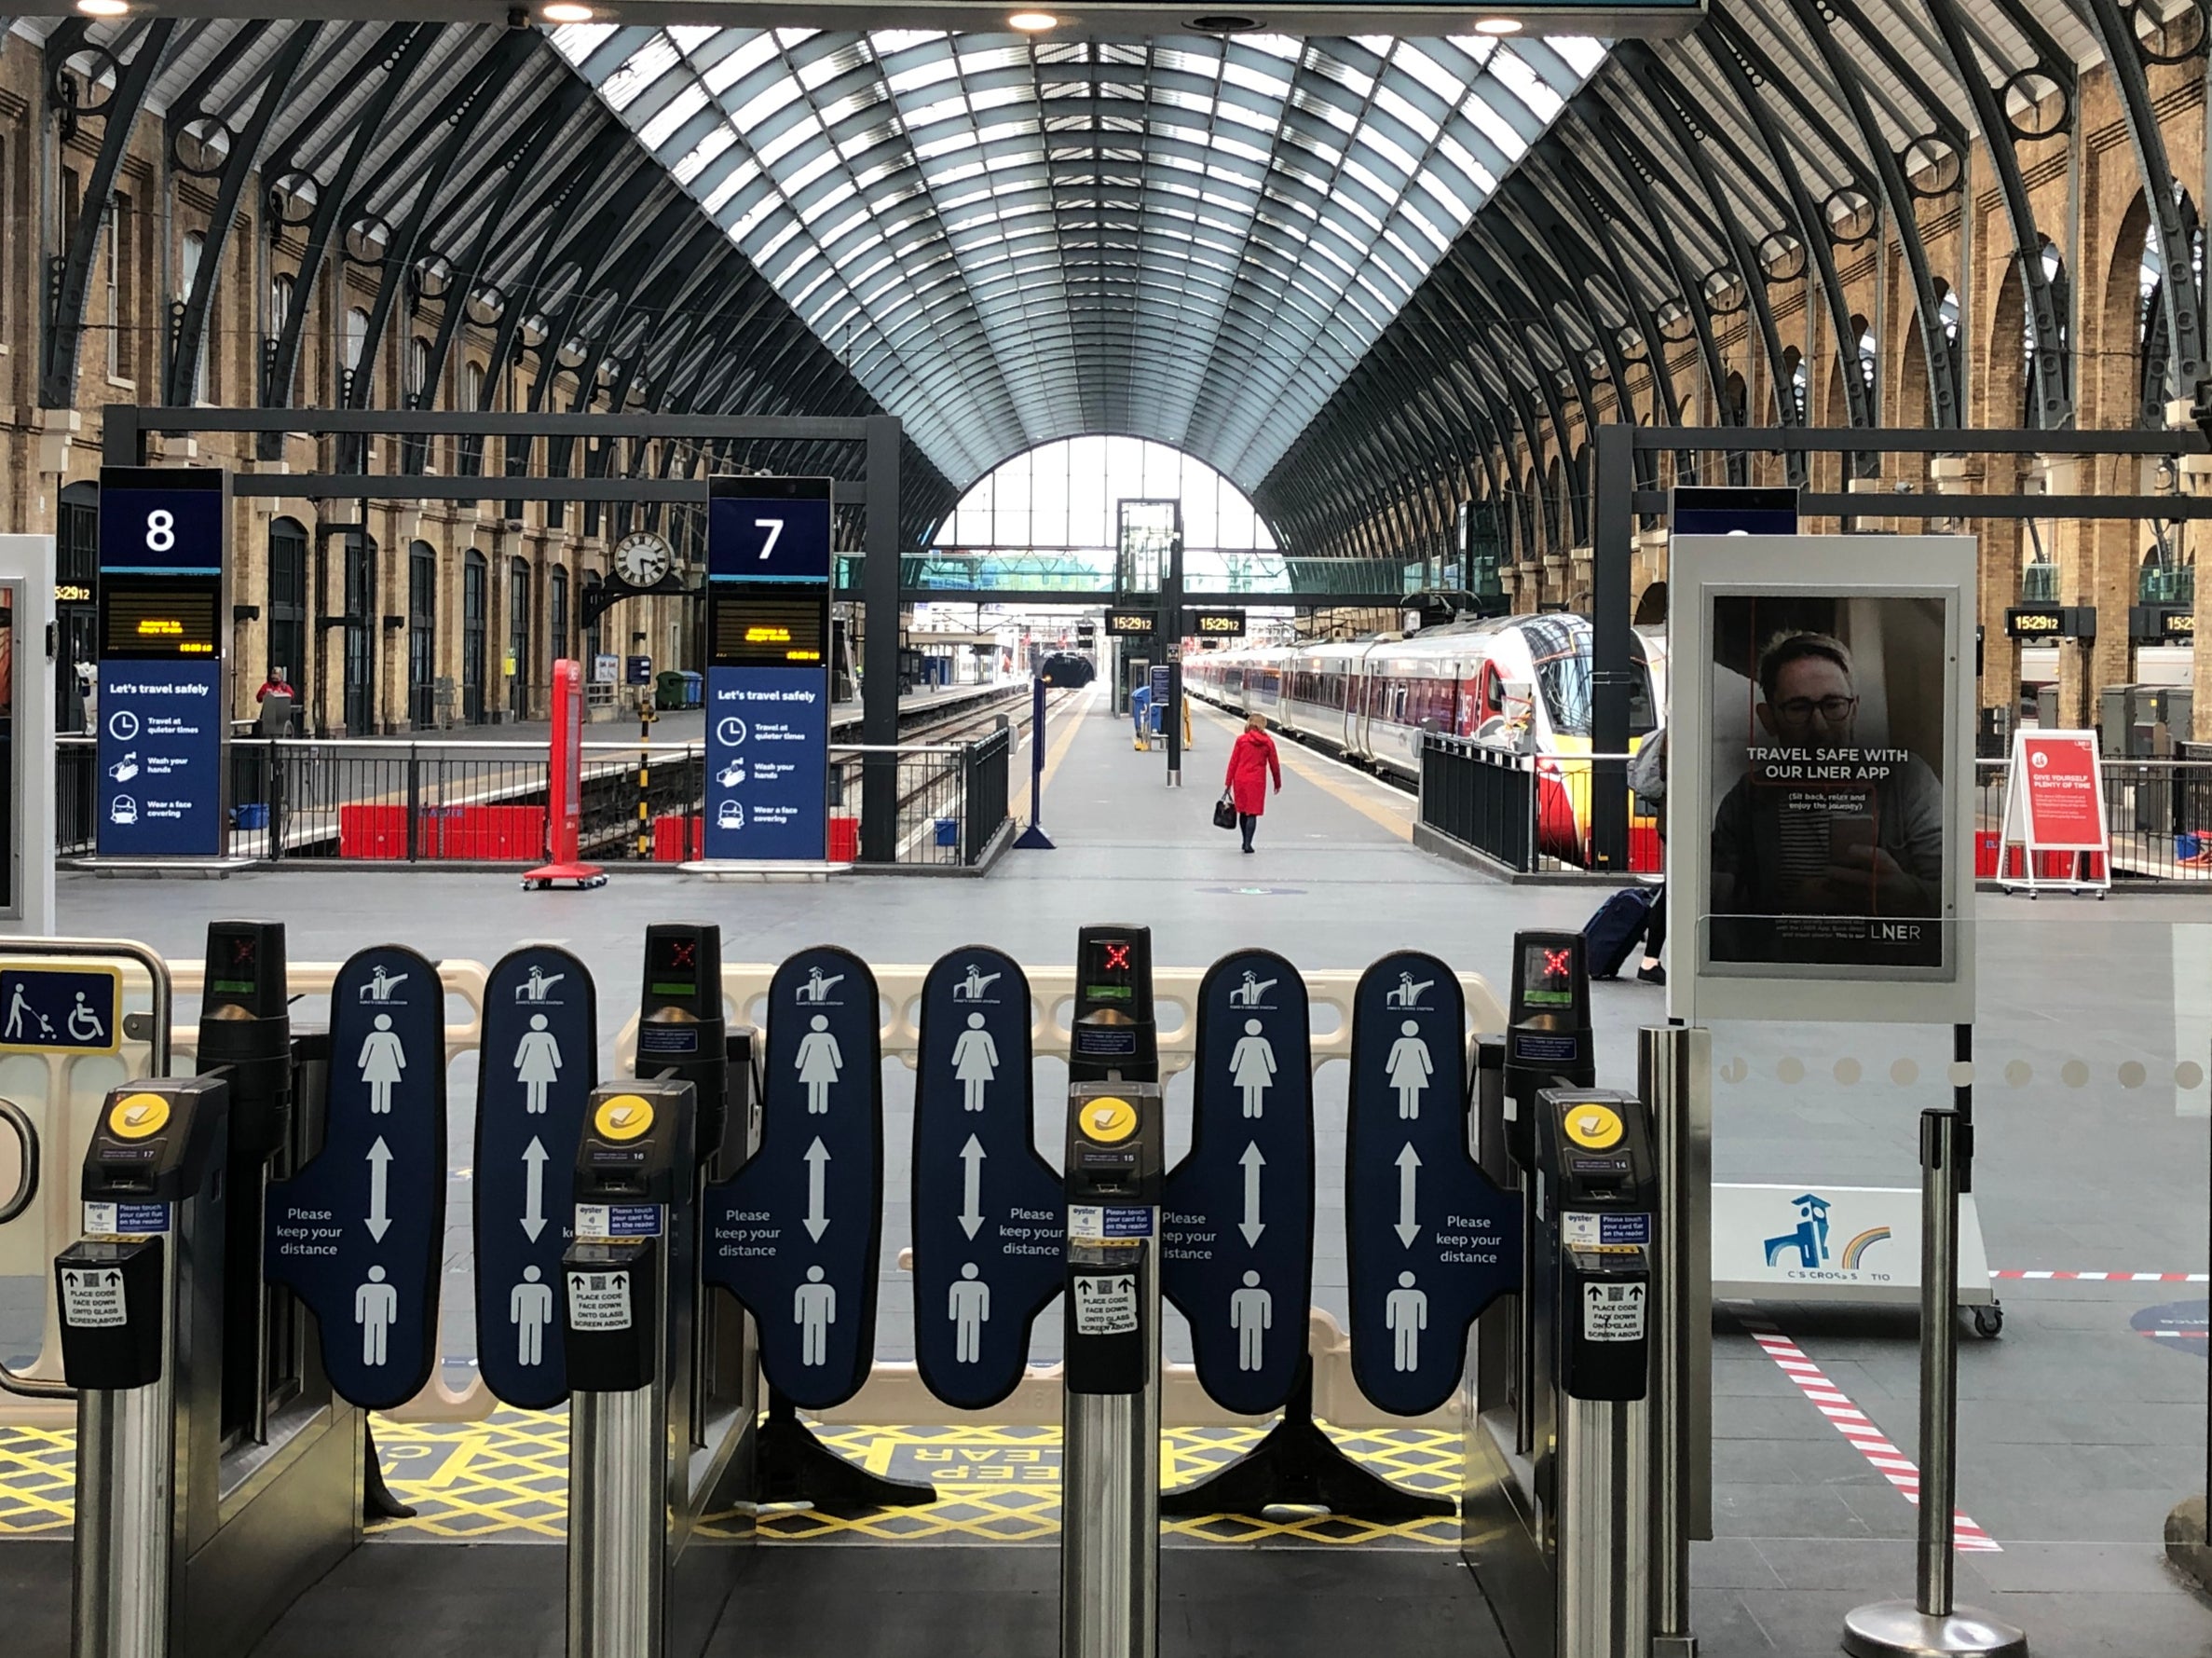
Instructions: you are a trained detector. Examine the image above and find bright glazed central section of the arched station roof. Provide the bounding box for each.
[553,24,1604,489]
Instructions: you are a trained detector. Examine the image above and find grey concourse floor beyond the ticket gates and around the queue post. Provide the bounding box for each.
[17,691,2212,1658]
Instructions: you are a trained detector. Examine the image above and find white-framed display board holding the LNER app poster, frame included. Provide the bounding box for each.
[1666,536,1980,1025]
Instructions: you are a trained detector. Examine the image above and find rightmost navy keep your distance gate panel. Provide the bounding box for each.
[1345,950,1520,1417]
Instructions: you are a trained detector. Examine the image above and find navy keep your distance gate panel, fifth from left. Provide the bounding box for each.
[1159,950,1314,1417]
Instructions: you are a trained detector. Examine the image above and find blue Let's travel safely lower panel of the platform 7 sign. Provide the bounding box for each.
[705,666,829,859]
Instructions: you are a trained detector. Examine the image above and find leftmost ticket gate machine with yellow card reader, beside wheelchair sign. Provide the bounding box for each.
[55,923,365,1658]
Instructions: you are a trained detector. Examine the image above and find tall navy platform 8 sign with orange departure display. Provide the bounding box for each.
[95,467,230,859]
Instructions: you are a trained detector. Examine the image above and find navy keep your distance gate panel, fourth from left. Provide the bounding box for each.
[913,945,1066,1410]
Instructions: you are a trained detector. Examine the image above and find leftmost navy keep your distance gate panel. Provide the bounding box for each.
[266,945,444,1410]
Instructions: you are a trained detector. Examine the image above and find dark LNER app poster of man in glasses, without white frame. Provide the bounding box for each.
[1708,594,1956,969]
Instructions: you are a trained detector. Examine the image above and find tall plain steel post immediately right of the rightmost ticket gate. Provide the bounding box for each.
[1637,1025,1712,1658]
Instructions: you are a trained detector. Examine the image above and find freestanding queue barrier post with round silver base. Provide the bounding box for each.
[1843,1109,2028,1658]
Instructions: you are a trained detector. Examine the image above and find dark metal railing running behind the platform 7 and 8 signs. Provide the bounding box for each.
[55,731,1011,866]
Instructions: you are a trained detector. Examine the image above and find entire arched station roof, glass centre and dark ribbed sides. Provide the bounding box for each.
[34,0,2132,551]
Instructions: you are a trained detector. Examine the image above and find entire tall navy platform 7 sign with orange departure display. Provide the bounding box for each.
[705,478,836,863]
